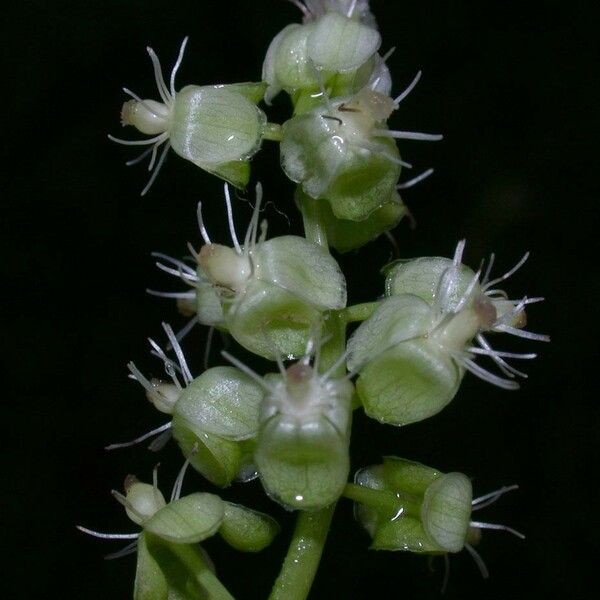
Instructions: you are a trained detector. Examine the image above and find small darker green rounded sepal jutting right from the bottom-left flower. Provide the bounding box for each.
[219,502,279,552]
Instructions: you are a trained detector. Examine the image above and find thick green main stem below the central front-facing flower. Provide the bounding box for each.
[269,504,335,600]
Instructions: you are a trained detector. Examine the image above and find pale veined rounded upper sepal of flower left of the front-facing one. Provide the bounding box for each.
[174,367,264,441]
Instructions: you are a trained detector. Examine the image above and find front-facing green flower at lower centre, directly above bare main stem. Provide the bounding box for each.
[254,361,353,510]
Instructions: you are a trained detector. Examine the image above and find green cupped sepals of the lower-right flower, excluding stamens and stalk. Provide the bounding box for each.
[355,457,472,554]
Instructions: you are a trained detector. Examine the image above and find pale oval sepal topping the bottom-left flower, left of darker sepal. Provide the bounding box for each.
[144,493,225,544]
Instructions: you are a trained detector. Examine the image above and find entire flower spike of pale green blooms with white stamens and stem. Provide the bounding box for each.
[80,0,548,600]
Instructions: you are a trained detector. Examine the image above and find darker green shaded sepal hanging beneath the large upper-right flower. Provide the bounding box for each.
[295,187,407,253]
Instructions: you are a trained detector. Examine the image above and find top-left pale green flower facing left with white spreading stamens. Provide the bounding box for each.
[111,38,267,194]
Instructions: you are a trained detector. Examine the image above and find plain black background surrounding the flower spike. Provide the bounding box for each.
[0,0,599,599]
